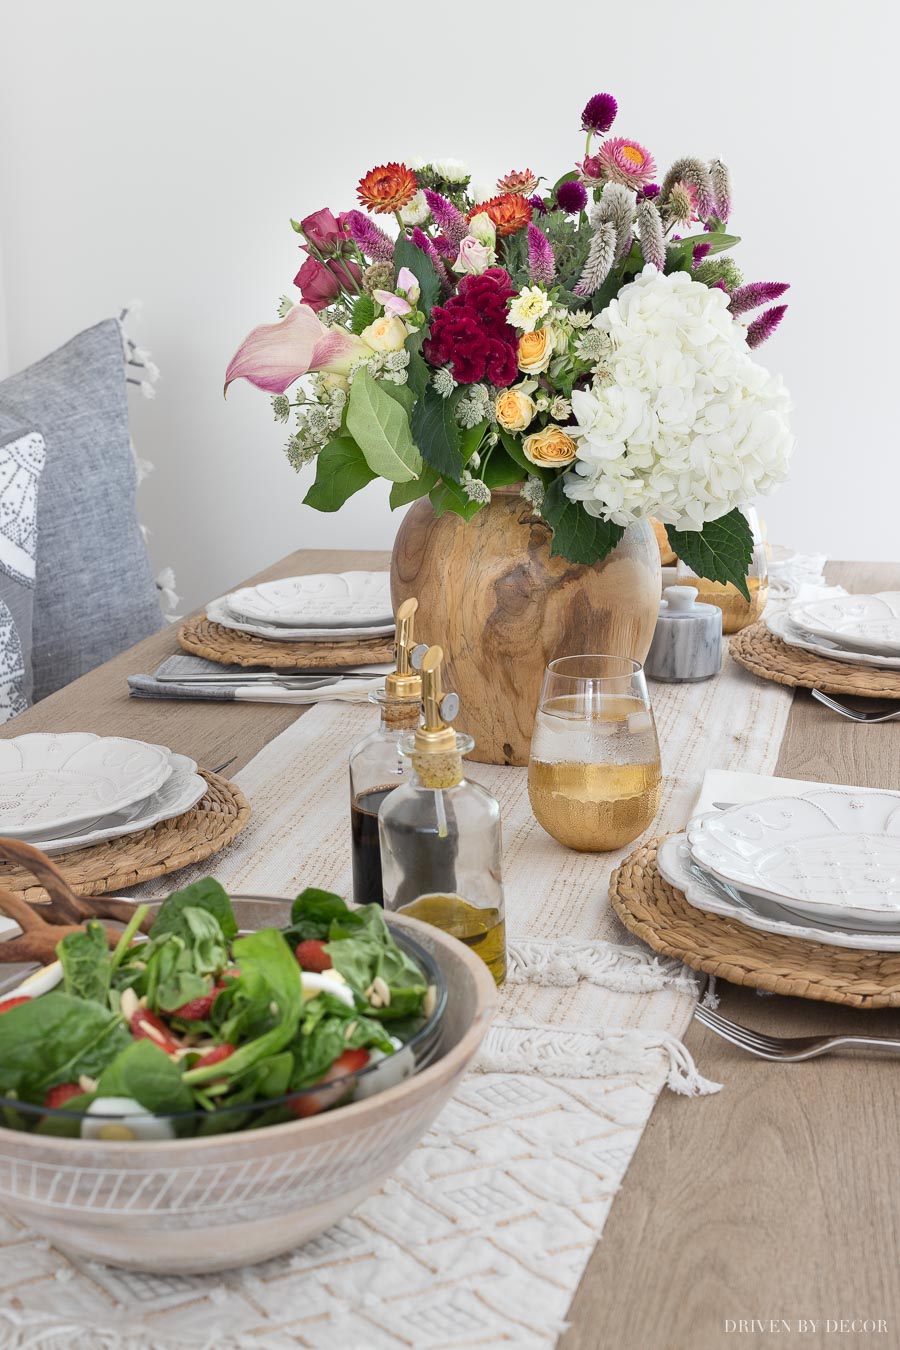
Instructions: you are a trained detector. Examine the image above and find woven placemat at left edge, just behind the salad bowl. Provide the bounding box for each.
[0,770,250,902]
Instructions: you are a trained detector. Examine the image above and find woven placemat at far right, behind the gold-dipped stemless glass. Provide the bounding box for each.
[729,621,900,698]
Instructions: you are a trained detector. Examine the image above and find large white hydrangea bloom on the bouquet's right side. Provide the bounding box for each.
[565,266,793,529]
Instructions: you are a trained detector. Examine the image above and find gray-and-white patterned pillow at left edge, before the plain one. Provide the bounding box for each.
[0,432,45,722]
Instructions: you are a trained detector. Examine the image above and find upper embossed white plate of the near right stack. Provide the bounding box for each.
[687,787,900,932]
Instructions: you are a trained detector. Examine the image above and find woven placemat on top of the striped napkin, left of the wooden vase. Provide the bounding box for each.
[178,614,394,670]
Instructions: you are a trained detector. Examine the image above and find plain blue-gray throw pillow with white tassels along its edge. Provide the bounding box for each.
[0,319,163,699]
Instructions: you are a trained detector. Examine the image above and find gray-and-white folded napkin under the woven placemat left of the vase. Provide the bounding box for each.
[128,653,394,703]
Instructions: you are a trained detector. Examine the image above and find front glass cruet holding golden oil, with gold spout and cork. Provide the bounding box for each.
[378,647,506,984]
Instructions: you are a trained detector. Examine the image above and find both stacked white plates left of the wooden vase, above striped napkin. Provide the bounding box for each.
[206,572,394,643]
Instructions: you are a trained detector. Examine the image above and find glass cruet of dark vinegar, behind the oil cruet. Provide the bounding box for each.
[349,597,425,905]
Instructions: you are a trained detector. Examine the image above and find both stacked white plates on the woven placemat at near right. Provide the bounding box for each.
[657,787,900,952]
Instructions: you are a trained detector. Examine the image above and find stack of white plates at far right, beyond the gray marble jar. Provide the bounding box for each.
[766,591,900,671]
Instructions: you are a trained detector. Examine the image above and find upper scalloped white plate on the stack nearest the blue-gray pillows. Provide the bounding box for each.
[225,572,394,629]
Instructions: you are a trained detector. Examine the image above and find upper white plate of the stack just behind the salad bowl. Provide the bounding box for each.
[0,732,171,840]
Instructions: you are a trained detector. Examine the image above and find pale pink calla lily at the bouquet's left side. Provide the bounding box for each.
[225,305,372,394]
